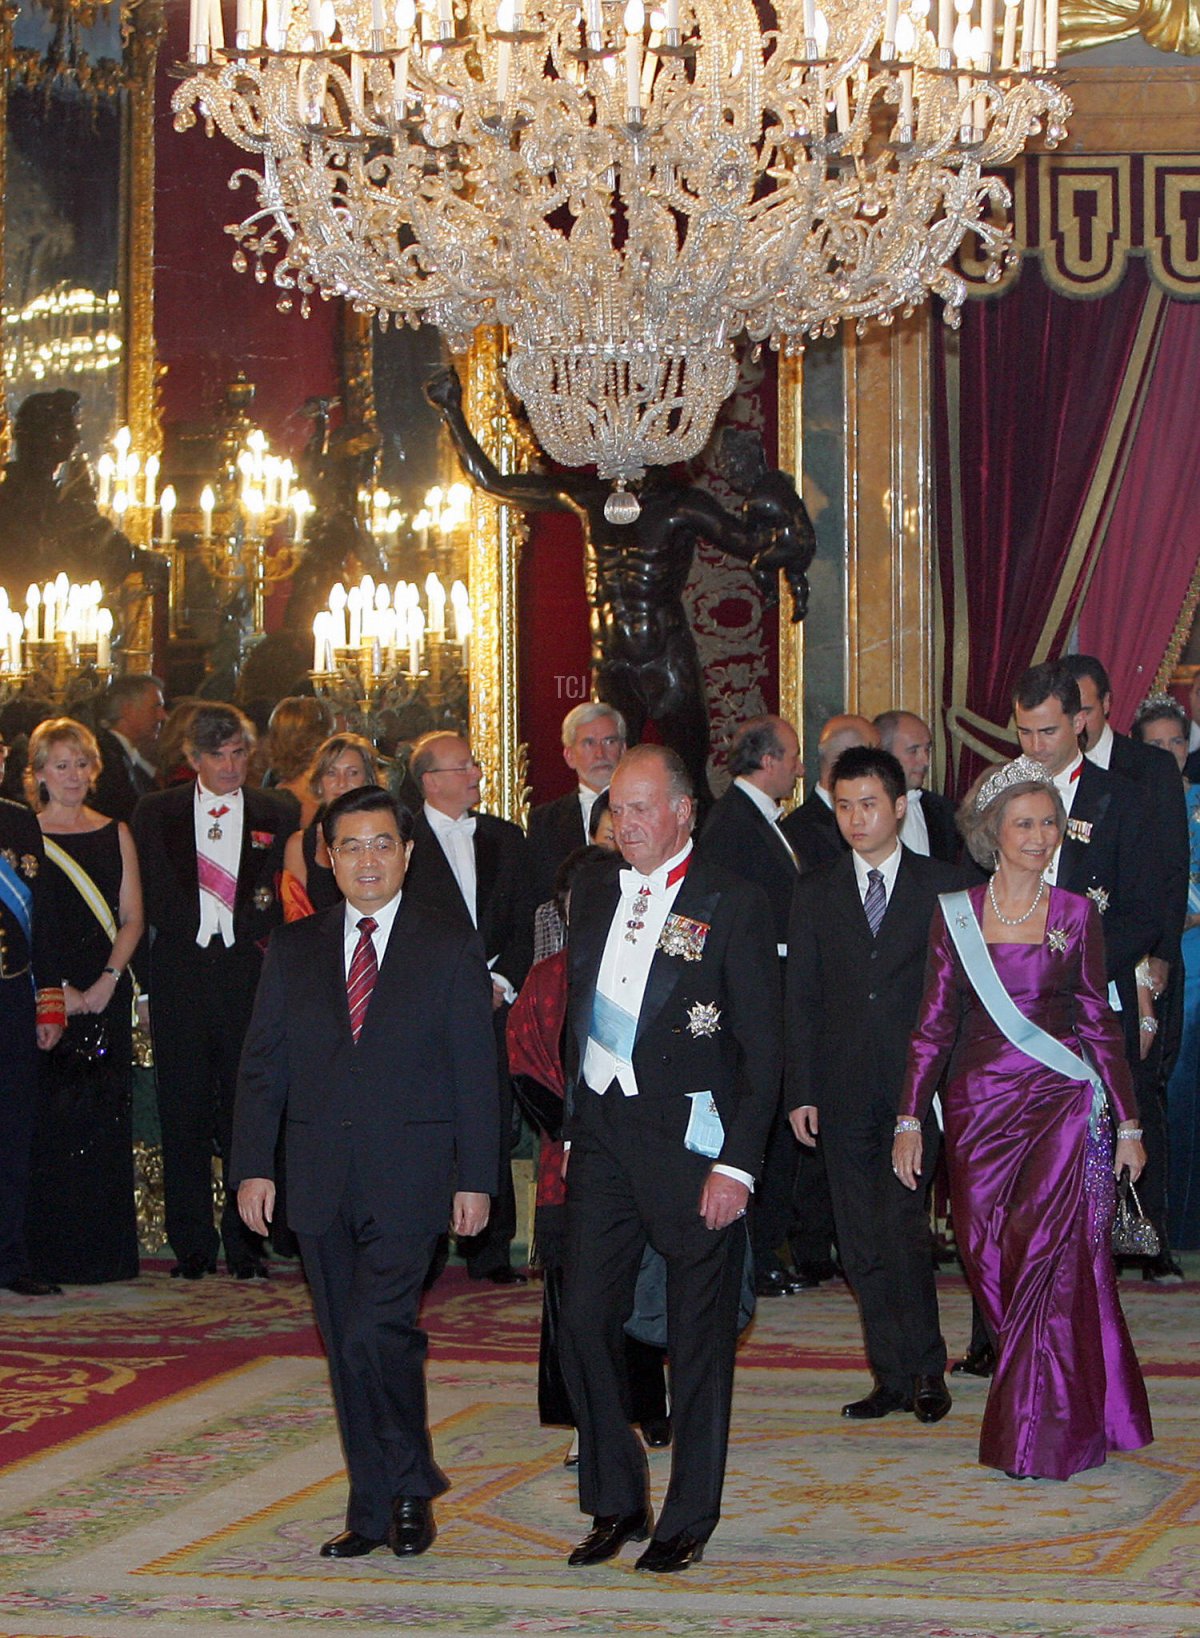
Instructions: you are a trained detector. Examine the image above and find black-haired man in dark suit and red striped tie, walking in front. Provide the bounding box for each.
[232,786,499,1558]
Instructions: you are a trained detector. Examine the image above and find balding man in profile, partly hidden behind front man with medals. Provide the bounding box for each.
[696,716,819,1297]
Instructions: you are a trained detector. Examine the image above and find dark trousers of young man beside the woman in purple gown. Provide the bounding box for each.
[820,1101,946,1394]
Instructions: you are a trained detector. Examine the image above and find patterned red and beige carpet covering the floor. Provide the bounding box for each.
[0,1260,1200,1638]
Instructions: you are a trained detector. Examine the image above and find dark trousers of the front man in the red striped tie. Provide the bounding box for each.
[298,1178,447,1541]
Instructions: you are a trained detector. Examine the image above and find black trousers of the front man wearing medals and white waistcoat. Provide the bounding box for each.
[562,1088,747,1540]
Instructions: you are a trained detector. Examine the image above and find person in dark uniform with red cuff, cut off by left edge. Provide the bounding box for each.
[0,779,70,1297]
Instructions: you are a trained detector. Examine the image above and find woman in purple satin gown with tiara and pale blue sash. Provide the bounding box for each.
[892,758,1153,1479]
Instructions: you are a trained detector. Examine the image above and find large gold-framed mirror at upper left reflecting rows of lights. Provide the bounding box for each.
[0,0,162,460]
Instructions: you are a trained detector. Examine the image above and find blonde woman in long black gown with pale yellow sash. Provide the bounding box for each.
[26,717,142,1286]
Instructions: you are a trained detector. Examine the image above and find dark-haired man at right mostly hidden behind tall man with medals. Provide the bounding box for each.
[1059,654,1192,1284]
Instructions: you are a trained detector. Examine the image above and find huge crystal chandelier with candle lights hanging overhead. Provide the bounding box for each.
[174,0,1071,513]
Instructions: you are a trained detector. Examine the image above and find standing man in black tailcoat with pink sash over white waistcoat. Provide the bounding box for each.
[133,704,290,1279]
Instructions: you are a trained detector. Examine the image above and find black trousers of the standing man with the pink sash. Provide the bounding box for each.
[151,935,262,1265]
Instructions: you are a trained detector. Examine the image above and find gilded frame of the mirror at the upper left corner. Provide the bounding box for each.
[0,0,165,454]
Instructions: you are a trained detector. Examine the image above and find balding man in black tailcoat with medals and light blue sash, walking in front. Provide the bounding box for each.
[562,745,783,1572]
